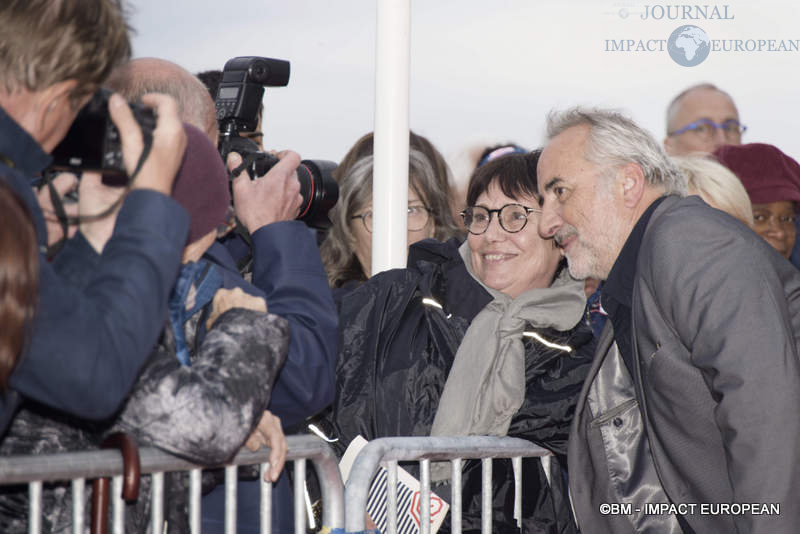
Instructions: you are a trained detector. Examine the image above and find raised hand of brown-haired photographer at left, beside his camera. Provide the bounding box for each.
[108,93,186,195]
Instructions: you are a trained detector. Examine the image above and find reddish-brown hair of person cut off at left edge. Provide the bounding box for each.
[0,178,39,391]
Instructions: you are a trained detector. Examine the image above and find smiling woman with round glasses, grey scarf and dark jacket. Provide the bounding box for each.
[329,152,594,532]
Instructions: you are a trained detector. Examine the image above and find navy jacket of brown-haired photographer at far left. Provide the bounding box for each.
[0,108,189,436]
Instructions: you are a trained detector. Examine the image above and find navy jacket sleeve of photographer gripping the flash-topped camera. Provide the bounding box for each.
[211,221,339,427]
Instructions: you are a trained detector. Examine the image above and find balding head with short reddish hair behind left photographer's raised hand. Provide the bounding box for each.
[106,58,219,144]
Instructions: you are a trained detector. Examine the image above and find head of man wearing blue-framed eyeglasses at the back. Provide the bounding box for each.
[664,83,747,156]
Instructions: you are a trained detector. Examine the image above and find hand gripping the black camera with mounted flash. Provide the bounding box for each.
[228,150,303,234]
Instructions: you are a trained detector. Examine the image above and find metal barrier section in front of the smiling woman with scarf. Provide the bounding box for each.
[344,436,550,534]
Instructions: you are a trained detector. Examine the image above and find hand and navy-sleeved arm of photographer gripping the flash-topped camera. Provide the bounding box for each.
[216,152,338,532]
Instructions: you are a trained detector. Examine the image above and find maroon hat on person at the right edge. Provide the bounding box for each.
[714,143,800,210]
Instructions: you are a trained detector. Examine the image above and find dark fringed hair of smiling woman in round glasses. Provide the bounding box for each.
[467,153,542,206]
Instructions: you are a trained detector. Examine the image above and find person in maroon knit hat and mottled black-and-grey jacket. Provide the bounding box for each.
[0,125,289,533]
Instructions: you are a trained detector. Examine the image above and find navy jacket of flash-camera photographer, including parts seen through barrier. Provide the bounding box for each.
[203,230,339,533]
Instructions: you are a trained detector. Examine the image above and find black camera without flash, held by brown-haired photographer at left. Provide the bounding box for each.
[50,88,156,186]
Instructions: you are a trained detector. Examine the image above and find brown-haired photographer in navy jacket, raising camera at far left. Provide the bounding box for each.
[0,0,188,433]
